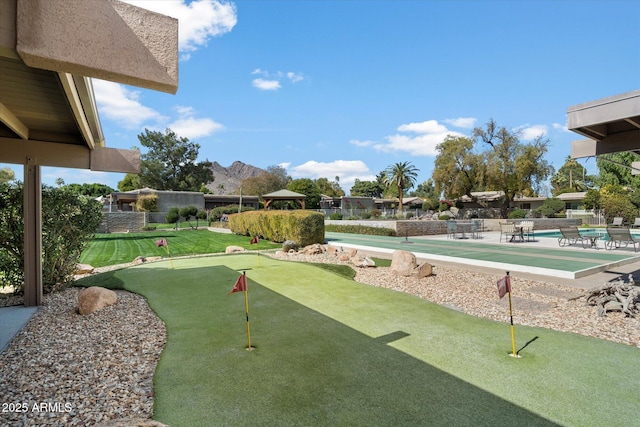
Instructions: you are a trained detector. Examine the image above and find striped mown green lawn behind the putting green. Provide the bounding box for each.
[80,230,282,267]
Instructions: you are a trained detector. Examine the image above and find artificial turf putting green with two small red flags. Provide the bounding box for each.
[76,255,640,426]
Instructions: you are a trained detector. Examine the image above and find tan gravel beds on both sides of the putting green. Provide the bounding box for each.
[0,252,640,426]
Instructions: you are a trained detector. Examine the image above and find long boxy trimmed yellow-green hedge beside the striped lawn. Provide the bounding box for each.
[229,210,324,246]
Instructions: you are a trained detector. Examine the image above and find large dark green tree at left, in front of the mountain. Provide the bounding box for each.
[138,129,214,191]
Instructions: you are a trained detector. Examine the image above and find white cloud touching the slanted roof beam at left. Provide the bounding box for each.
[93,79,165,129]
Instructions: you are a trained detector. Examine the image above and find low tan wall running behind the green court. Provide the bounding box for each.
[325,218,582,237]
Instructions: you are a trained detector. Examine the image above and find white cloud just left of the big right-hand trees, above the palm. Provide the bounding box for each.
[371,120,464,156]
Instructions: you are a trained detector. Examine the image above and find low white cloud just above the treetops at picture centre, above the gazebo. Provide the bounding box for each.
[286,160,376,194]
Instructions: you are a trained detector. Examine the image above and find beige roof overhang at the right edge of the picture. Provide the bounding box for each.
[567,90,640,171]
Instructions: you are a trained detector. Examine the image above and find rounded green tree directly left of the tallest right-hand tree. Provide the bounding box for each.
[432,135,484,199]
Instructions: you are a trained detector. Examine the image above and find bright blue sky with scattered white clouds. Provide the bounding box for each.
[0,0,640,194]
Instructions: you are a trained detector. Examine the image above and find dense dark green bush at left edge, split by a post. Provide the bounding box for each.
[0,183,102,294]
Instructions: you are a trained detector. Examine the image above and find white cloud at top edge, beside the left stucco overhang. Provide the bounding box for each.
[125,0,238,59]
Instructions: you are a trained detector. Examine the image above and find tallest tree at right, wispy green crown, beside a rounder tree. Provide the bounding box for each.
[473,119,553,218]
